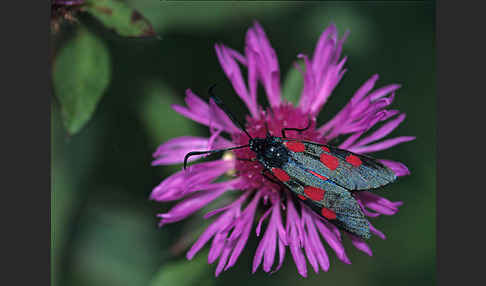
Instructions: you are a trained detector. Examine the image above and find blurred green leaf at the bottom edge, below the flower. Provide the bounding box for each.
[150,252,214,286]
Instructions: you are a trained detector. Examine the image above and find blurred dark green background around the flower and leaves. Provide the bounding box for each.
[51,0,436,286]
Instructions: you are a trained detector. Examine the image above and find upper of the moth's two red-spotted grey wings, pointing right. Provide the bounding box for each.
[283,139,396,191]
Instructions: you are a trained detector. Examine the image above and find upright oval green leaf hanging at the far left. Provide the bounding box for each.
[53,28,111,134]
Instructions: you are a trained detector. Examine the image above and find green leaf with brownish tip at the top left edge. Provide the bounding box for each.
[84,0,155,37]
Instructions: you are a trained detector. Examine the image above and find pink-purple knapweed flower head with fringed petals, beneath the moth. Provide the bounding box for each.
[150,23,414,277]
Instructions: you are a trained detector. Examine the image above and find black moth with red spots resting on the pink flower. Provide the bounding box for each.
[184,85,397,239]
